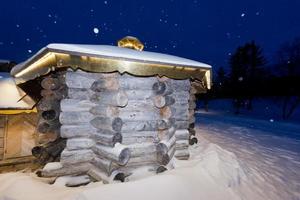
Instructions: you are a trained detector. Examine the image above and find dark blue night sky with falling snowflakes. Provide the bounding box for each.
[0,0,300,68]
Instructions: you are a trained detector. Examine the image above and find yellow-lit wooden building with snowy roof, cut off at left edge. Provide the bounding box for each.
[0,72,37,172]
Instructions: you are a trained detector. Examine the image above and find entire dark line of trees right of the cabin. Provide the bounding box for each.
[202,37,300,119]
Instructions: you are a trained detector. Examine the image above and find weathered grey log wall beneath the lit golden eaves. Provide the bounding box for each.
[40,70,195,182]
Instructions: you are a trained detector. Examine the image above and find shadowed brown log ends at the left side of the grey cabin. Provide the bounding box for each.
[32,71,67,164]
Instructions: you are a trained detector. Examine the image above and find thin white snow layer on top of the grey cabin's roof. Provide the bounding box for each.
[46,44,211,69]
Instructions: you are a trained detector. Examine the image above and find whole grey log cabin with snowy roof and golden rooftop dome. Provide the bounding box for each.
[7,36,211,186]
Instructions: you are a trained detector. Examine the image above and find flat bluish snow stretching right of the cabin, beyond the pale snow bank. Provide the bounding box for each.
[197,111,300,200]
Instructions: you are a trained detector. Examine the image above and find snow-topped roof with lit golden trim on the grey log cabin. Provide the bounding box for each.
[11,44,211,88]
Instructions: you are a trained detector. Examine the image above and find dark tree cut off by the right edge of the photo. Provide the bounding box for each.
[277,38,300,119]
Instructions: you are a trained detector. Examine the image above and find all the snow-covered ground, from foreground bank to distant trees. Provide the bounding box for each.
[0,100,300,200]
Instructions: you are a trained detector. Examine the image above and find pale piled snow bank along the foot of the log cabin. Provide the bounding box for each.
[0,138,247,200]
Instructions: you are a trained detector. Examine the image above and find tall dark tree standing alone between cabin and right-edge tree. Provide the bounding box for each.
[229,41,266,113]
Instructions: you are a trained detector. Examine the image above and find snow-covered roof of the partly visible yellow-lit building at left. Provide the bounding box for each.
[0,72,34,110]
